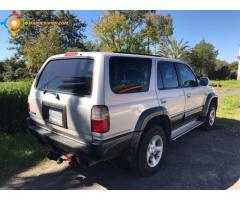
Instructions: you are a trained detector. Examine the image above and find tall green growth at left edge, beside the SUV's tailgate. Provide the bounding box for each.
[0,81,31,132]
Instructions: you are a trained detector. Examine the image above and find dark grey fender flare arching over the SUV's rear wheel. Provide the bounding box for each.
[130,106,170,161]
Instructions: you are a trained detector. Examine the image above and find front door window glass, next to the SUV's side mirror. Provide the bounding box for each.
[177,63,197,87]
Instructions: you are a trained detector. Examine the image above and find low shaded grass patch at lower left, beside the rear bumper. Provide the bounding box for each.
[0,132,47,185]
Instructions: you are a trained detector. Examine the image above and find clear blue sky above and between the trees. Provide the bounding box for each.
[0,11,240,62]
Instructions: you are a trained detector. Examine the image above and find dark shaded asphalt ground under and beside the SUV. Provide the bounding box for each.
[2,119,240,189]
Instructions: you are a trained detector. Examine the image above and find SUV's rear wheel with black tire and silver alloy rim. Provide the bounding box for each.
[133,125,166,176]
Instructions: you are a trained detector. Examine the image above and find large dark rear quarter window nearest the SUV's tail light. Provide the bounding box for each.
[109,57,152,94]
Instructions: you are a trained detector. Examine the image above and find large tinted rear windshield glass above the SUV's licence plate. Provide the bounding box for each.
[37,58,93,96]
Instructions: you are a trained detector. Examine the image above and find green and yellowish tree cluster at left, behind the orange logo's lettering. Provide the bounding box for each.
[0,10,86,80]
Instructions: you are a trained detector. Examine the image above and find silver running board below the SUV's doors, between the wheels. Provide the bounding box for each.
[171,120,203,140]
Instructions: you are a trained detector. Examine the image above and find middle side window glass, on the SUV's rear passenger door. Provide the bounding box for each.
[158,61,179,89]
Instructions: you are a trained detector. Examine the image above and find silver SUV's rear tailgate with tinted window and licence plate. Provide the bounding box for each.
[29,58,94,141]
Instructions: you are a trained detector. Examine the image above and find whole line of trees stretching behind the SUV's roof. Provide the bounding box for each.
[0,10,237,81]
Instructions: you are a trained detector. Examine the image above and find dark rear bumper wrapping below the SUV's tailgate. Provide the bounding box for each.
[27,118,133,161]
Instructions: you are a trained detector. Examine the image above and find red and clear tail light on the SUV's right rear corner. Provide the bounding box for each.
[91,105,110,133]
